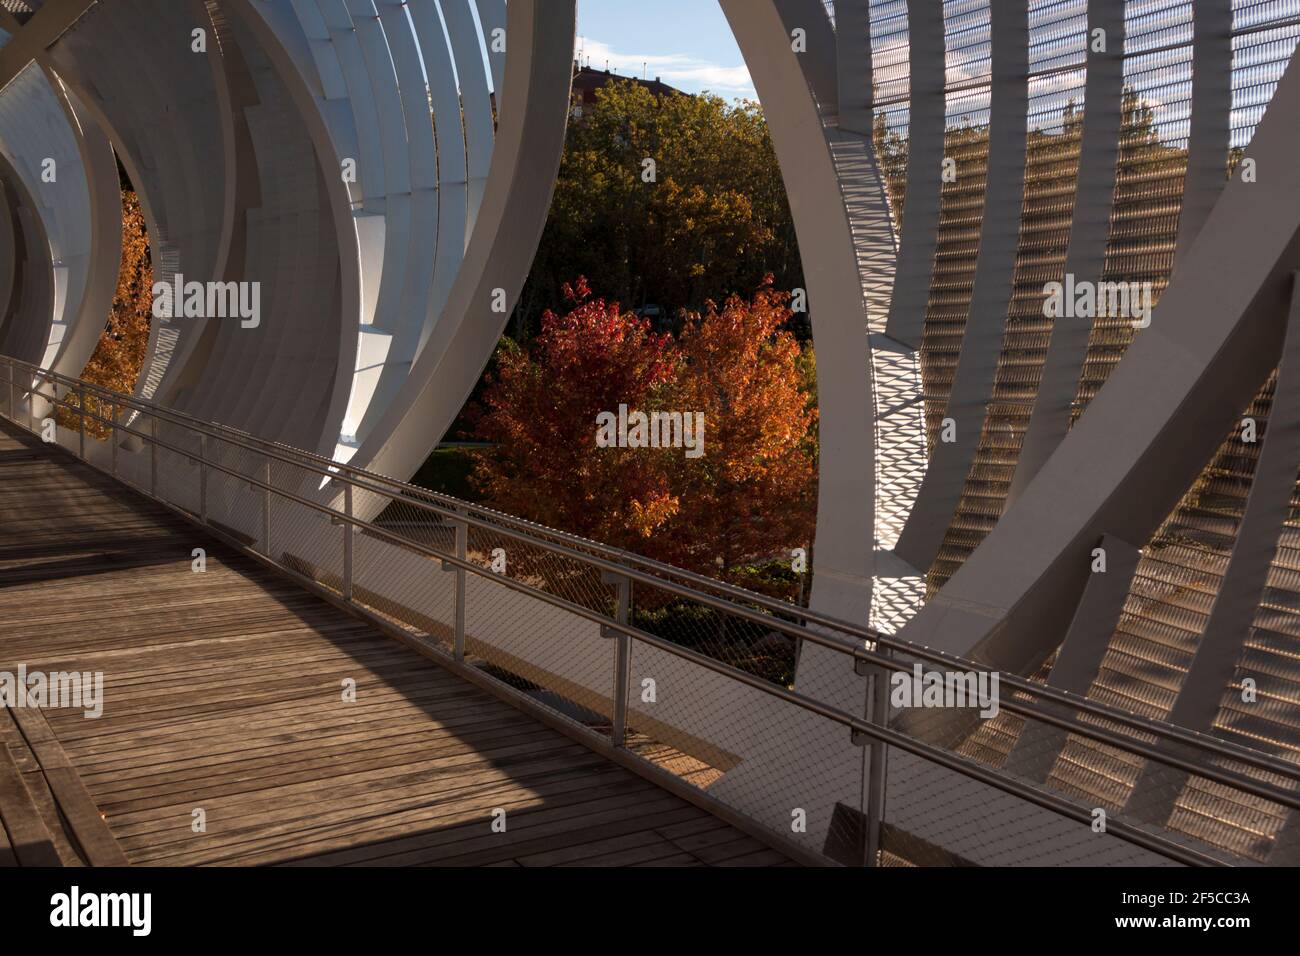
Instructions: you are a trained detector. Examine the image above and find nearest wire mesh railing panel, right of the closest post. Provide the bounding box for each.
[887,693,1296,865]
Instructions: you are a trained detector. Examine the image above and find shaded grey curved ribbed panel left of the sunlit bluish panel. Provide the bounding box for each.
[185,5,355,451]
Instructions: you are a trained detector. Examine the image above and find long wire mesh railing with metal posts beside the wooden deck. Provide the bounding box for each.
[0,360,1300,865]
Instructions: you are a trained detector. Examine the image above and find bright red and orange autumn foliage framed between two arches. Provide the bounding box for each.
[473,277,816,595]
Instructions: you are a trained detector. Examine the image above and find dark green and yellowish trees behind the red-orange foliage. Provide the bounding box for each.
[515,82,802,337]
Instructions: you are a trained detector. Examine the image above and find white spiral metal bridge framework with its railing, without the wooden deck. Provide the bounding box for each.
[0,0,1300,865]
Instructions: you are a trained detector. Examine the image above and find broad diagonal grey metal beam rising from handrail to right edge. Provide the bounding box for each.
[901,44,1300,672]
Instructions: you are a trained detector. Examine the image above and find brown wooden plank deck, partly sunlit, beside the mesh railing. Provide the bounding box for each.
[0,423,788,866]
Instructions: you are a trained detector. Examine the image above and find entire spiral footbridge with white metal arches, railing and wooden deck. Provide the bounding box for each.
[0,0,1300,866]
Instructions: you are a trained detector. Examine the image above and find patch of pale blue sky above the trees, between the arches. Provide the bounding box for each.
[577,0,758,100]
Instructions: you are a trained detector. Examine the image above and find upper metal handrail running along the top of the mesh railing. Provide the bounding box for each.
[10,356,1300,790]
